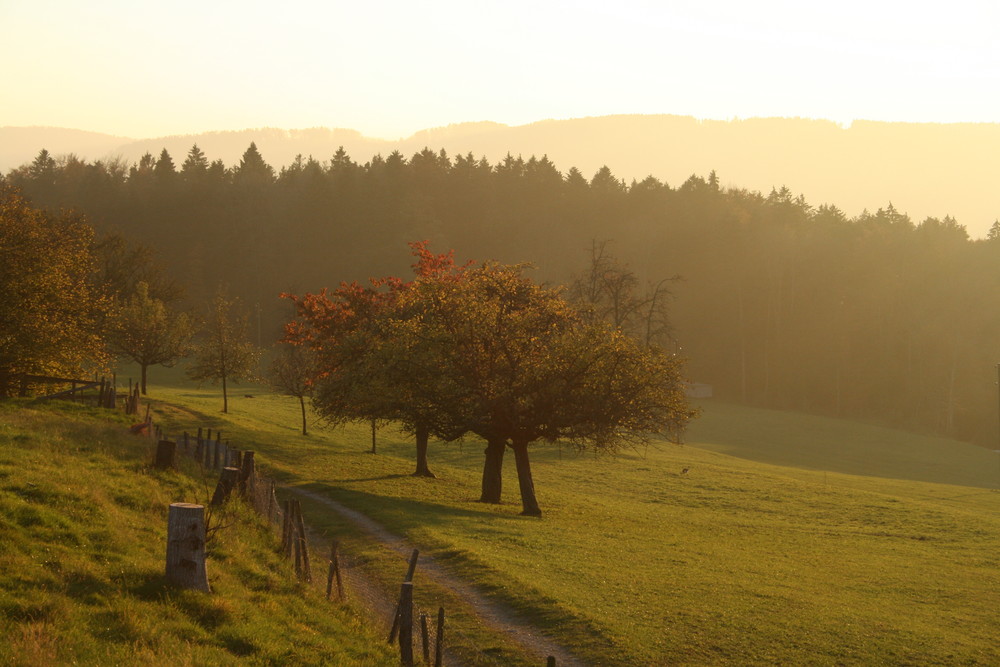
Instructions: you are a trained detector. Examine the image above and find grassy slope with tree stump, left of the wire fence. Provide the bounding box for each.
[0,400,396,667]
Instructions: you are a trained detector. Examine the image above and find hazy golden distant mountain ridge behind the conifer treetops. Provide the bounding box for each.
[0,115,1000,236]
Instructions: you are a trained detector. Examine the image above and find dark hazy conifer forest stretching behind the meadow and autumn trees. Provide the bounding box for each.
[5,145,1000,445]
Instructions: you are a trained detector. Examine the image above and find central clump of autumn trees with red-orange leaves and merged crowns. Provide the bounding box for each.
[288,244,693,516]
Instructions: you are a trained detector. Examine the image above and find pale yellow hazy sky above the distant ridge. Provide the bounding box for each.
[0,0,1000,139]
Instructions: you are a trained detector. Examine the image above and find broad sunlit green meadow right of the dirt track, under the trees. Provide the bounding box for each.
[143,376,1000,665]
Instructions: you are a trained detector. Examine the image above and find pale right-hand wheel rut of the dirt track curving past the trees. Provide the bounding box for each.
[285,487,584,667]
